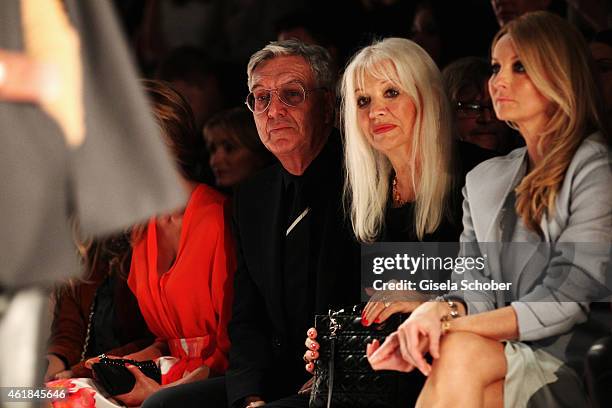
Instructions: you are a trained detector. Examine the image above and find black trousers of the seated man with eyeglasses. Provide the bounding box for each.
[142,377,309,408]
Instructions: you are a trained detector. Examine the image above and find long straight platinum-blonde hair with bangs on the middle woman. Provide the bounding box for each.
[341,38,454,242]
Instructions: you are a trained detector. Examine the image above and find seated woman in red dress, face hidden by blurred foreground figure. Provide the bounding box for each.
[49,81,235,407]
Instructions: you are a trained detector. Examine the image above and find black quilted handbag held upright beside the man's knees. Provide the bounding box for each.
[309,307,425,408]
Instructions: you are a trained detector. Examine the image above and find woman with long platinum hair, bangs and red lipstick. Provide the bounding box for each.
[304,38,491,386]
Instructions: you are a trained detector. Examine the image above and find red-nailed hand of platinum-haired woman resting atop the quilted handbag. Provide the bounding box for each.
[361,289,423,326]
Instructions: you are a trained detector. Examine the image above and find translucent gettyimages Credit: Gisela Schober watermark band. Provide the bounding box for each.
[361,242,612,301]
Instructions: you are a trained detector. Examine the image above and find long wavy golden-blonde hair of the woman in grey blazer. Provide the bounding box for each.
[491,11,609,233]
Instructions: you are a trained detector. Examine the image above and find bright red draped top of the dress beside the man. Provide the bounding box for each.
[128,184,236,384]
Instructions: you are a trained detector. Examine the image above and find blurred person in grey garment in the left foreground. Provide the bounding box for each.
[0,0,186,407]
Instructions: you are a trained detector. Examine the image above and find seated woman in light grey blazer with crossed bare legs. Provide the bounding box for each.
[367,12,612,407]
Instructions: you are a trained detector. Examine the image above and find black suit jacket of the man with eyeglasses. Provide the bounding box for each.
[226,133,360,405]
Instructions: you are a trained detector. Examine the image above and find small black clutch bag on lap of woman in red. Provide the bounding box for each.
[91,356,161,397]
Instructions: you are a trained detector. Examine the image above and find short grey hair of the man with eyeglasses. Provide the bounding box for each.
[247,39,336,90]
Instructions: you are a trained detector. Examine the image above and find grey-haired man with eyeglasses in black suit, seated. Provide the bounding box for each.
[143,40,360,408]
